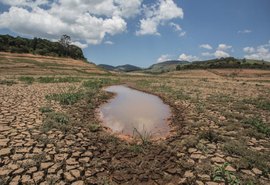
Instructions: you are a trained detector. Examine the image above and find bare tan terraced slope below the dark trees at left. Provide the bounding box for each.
[0,52,107,75]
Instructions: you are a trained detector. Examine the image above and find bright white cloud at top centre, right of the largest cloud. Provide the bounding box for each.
[136,0,184,35]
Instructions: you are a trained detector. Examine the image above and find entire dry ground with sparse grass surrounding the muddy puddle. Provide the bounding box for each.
[0,67,270,185]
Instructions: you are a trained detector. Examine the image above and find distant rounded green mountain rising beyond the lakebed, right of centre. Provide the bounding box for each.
[145,60,189,73]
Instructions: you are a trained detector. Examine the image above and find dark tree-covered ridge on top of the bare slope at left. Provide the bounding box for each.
[0,35,85,60]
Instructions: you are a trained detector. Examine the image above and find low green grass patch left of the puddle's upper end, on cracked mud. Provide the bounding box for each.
[46,93,84,105]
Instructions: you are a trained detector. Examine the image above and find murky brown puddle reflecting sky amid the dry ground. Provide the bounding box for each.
[99,85,171,137]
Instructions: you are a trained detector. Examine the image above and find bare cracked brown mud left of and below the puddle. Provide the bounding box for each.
[0,76,270,185]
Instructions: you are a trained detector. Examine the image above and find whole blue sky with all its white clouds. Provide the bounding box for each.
[0,0,270,67]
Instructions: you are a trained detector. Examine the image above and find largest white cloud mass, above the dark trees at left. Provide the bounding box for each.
[0,0,143,46]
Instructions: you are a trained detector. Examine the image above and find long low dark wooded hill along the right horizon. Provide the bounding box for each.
[176,57,270,70]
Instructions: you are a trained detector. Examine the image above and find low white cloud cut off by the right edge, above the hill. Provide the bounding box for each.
[243,40,270,61]
